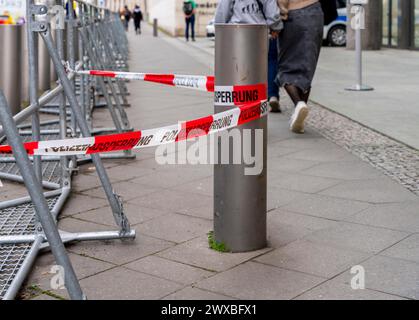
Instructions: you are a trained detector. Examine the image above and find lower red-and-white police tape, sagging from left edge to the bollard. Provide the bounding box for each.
[0,100,268,156]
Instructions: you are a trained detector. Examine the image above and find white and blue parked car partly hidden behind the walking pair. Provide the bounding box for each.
[207,0,347,47]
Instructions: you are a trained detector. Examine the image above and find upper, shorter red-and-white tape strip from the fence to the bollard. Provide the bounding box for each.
[75,70,214,92]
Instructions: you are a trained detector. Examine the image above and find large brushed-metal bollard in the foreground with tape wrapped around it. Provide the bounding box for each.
[214,24,268,252]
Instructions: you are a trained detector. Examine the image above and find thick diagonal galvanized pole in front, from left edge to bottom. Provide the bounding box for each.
[0,91,85,300]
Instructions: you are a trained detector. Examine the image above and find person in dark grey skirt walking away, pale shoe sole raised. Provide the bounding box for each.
[276,0,331,133]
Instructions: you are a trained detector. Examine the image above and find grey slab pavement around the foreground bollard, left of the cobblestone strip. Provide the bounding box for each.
[21,26,419,299]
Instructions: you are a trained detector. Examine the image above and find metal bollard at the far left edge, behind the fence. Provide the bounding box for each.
[0,25,22,114]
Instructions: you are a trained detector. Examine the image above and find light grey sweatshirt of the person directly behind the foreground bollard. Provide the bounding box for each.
[215,0,283,31]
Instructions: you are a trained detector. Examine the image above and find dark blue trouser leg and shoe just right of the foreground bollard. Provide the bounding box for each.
[268,39,281,112]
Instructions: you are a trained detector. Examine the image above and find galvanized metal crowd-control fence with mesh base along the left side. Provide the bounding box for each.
[0,0,135,299]
